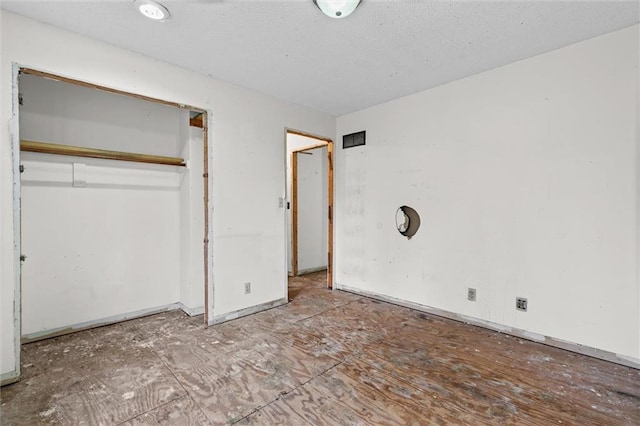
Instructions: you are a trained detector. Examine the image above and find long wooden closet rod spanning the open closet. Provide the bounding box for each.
[20,140,185,166]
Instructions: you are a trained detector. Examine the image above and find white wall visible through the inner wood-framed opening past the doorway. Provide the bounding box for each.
[297,146,328,274]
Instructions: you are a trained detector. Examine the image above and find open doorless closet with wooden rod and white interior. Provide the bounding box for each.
[14,68,209,345]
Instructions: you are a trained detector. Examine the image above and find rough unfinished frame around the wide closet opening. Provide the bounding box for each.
[6,62,212,385]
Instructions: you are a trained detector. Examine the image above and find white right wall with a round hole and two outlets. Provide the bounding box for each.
[335,25,640,362]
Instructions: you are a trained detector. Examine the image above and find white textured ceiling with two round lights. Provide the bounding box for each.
[2,0,640,116]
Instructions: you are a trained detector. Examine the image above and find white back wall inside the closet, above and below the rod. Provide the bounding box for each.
[19,75,182,337]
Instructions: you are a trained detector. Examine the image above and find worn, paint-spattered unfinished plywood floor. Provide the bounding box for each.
[0,273,640,425]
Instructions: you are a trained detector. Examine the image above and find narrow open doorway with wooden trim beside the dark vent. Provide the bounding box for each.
[286,129,333,289]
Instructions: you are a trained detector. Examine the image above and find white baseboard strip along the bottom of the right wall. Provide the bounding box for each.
[335,283,640,370]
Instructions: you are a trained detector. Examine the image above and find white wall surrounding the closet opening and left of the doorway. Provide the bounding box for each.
[0,11,335,379]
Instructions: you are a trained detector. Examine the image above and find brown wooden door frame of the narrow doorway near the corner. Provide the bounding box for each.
[286,129,334,289]
